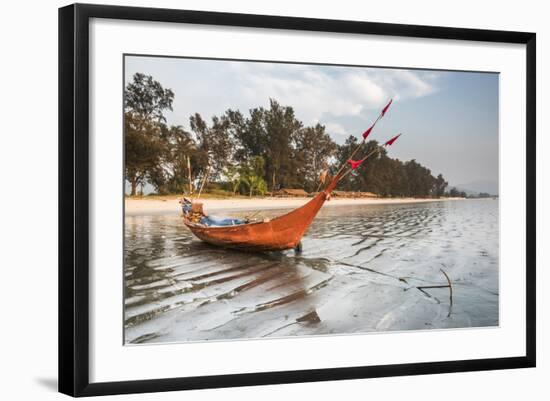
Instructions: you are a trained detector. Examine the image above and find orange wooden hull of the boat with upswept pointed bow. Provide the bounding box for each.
[183,174,342,252]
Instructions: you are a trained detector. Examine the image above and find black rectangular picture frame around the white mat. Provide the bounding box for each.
[58,4,536,396]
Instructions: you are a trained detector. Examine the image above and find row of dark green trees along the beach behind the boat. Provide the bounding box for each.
[124,73,448,197]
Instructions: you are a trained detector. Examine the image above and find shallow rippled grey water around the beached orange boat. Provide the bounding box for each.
[124,200,499,343]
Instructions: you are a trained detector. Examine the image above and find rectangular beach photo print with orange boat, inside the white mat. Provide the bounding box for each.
[121,55,499,344]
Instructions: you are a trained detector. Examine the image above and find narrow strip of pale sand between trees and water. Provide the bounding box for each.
[125,198,462,216]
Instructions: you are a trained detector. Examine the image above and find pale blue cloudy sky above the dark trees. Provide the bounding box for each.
[125,56,499,193]
